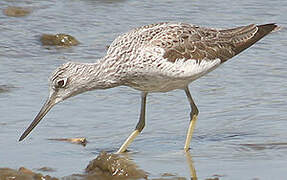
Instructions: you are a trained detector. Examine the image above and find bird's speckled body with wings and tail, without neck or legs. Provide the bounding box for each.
[104,23,277,91]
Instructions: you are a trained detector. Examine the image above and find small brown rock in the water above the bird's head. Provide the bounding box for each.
[40,34,79,47]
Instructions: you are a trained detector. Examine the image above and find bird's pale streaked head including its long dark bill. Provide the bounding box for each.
[19,62,89,141]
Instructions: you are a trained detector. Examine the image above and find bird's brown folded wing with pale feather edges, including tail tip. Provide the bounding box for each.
[151,23,276,63]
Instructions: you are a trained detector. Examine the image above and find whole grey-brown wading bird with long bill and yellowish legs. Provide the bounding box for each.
[19,22,277,153]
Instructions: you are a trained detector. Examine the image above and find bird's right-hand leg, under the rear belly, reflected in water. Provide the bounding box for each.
[184,87,199,152]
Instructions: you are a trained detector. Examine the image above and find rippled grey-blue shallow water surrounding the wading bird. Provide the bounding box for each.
[0,0,287,179]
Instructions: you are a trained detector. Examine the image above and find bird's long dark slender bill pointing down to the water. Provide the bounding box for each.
[19,96,56,141]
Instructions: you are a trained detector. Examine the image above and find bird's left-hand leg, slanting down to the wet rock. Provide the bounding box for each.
[117,92,147,153]
